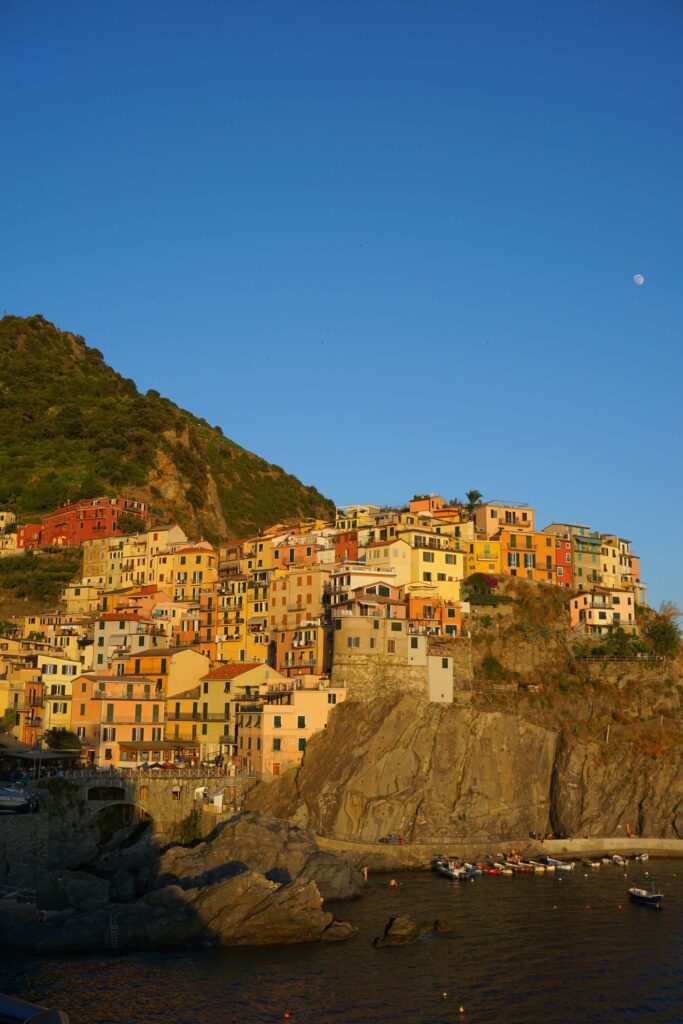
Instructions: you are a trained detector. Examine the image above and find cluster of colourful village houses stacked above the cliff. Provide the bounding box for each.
[0,495,646,776]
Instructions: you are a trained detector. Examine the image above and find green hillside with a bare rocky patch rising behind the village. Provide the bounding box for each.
[0,316,334,540]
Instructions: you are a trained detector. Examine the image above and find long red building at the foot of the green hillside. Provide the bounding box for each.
[16,498,150,548]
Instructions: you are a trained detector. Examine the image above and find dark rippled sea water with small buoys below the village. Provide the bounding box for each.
[0,860,683,1024]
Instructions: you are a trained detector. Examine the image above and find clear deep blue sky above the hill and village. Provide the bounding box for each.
[0,0,683,603]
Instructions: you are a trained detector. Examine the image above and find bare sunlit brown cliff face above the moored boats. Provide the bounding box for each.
[249,696,683,842]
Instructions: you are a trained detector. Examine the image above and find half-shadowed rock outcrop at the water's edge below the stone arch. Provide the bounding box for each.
[0,814,362,953]
